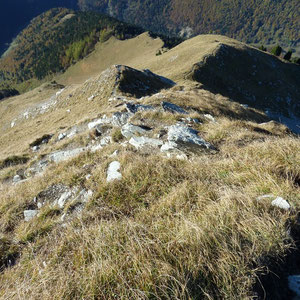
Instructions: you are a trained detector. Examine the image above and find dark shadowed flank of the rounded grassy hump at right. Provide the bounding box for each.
[186,43,300,133]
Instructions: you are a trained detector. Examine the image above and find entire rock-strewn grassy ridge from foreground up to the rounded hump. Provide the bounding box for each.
[0,33,300,300]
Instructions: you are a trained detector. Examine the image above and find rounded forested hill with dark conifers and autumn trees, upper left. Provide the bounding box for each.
[0,8,182,88]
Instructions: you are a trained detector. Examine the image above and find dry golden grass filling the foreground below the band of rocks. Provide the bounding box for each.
[0,127,300,299]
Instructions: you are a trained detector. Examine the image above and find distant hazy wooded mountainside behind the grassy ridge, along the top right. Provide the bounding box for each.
[78,0,300,48]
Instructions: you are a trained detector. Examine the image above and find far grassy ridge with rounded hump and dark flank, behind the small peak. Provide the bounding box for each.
[56,33,300,133]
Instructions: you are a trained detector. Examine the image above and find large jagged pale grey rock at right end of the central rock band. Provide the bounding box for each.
[168,124,216,150]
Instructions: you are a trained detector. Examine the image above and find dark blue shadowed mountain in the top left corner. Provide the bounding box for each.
[0,0,77,54]
